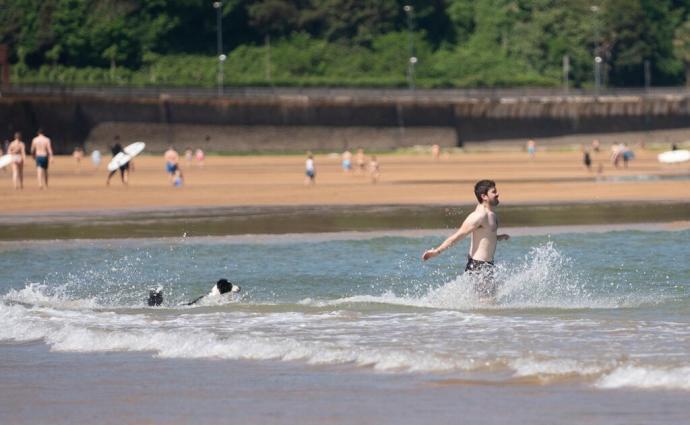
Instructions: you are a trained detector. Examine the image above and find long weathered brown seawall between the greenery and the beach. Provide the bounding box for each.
[0,93,690,153]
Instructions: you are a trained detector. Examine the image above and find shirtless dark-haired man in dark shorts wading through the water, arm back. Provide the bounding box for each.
[422,180,510,300]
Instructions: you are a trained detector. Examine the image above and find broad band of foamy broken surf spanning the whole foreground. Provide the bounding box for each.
[0,294,690,389]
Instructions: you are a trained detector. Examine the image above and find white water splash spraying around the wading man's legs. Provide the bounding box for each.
[302,242,663,310]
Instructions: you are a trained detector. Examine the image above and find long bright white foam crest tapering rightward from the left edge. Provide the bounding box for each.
[0,306,484,372]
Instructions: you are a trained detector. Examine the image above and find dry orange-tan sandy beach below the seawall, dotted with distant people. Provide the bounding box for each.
[0,150,690,215]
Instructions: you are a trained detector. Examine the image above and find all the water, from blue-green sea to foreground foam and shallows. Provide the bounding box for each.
[0,229,690,423]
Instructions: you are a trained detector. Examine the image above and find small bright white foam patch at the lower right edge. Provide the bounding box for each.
[595,365,690,390]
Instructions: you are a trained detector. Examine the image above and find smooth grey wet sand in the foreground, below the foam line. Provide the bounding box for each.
[0,343,687,425]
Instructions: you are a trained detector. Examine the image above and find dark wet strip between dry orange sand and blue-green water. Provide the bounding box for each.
[0,201,690,241]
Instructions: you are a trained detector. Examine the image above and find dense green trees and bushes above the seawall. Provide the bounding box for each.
[0,0,690,87]
